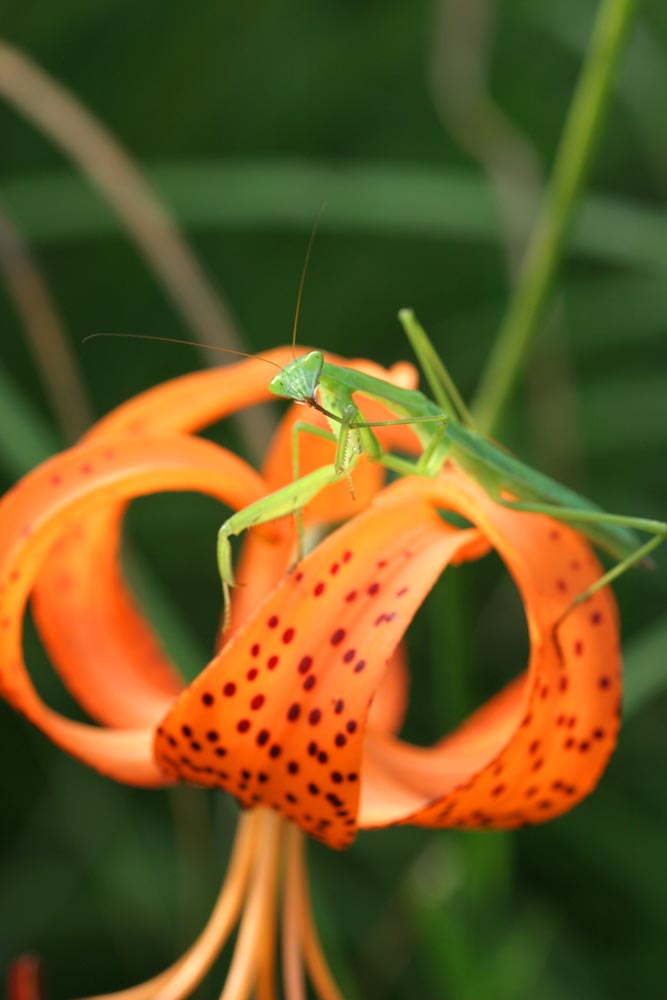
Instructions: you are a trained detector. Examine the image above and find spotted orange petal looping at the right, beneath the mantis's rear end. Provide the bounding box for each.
[359,470,621,828]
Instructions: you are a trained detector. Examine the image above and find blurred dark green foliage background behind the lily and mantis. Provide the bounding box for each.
[0,0,667,1000]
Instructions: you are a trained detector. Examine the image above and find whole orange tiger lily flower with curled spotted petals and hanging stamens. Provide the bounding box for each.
[0,349,620,1000]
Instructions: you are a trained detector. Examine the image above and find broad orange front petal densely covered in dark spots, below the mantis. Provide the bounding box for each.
[156,493,488,847]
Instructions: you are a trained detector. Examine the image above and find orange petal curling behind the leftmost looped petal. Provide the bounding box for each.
[33,348,298,726]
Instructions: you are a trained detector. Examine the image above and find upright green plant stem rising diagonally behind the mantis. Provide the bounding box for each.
[472,0,637,434]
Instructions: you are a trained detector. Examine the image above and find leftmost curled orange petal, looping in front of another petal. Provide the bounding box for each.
[0,435,264,784]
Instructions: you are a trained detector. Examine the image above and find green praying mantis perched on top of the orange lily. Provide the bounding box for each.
[217,309,667,624]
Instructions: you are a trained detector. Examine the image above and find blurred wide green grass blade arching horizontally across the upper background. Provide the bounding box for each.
[0,159,667,272]
